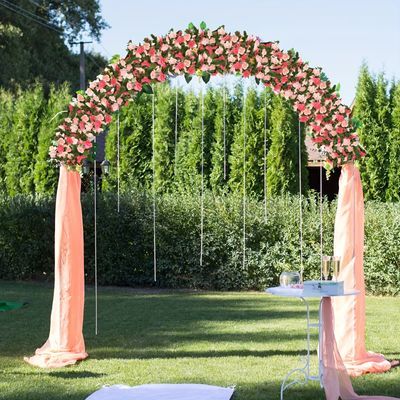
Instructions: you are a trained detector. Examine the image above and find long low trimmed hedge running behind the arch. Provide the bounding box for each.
[0,191,400,295]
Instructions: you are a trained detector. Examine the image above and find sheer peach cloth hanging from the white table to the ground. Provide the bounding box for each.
[322,296,399,400]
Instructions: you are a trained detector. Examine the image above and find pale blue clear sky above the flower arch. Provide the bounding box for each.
[89,0,400,104]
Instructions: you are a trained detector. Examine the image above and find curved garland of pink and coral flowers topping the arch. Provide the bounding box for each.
[49,23,365,169]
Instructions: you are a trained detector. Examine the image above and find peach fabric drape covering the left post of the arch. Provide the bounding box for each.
[25,166,88,368]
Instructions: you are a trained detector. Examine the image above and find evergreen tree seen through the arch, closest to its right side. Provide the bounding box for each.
[267,96,308,196]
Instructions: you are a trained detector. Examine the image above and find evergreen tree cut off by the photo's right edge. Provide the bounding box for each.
[386,84,400,201]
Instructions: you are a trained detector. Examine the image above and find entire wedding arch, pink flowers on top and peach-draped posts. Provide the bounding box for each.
[26,23,380,368]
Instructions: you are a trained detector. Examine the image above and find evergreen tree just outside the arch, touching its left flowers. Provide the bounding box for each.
[34,84,71,194]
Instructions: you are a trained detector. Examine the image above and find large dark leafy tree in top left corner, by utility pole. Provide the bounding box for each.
[0,0,107,90]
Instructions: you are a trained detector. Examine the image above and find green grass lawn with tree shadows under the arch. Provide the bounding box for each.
[0,282,400,400]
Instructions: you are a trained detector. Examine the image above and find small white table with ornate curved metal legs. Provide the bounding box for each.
[265,287,360,400]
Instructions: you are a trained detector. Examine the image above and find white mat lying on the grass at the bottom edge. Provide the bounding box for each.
[86,384,234,400]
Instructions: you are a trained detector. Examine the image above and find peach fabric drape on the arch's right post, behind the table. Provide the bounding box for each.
[333,164,390,376]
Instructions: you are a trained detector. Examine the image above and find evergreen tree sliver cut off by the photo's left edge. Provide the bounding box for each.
[0,88,14,193]
